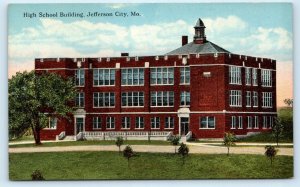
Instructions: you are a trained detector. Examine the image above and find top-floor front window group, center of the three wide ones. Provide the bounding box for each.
[122,68,144,85]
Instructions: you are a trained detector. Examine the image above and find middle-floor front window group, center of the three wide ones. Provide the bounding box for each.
[122,92,144,106]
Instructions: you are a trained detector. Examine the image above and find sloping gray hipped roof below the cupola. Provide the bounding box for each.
[165,41,230,55]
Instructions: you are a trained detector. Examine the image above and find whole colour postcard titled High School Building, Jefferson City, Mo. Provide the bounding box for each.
[8,3,294,181]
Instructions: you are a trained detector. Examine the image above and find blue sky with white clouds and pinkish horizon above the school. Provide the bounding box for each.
[8,3,293,106]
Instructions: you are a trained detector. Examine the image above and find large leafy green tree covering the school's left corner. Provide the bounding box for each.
[8,71,76,145]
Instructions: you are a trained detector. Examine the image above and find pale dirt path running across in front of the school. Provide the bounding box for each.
[8,144,294,156]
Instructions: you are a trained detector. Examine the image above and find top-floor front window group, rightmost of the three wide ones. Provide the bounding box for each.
[151,68,174,85]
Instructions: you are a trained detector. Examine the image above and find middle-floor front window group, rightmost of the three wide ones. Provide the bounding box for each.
[151,91,174,106]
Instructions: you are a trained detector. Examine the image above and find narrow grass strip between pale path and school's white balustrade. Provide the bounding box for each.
[9,140,171,148]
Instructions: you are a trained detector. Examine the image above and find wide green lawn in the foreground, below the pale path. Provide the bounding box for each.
[9,152,293,180]
